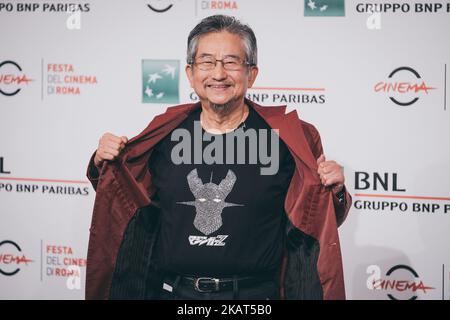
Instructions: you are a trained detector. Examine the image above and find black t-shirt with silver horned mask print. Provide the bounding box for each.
[149,108,295,276]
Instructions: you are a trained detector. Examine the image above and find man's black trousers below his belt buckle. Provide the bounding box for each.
[160,277,280,300]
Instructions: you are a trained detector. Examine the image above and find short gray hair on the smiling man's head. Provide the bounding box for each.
[186,15,258,66]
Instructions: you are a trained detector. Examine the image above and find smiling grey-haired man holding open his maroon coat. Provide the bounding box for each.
[86,15,351,299]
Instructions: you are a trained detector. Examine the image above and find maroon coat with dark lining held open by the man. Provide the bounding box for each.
[86,99,351,299]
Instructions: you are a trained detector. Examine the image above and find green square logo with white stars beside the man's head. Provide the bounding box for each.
[142,60,180,103]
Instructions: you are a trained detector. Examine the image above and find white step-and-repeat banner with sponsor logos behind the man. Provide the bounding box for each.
[0,0,450,300]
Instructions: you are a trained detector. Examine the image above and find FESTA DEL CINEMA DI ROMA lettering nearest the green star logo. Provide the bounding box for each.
[42,62,98,96]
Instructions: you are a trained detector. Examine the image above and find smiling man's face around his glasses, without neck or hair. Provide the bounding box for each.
[186,31,258,109]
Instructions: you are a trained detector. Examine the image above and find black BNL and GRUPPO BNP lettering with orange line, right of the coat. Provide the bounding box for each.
[353,171,450,214]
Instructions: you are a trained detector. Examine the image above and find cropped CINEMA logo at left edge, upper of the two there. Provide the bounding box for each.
[0,60,34,97]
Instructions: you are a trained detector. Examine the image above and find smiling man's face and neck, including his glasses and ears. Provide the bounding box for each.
[186,27,258,133]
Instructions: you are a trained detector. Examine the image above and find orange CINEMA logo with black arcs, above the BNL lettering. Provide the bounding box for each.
[374,67,436,107]
